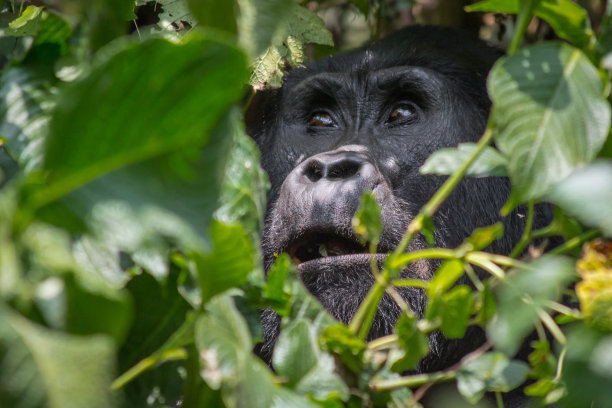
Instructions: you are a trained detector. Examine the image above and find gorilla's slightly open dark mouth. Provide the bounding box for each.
[286,233,368,265]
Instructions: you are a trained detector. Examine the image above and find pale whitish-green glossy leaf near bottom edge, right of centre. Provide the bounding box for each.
[457,352,529,404]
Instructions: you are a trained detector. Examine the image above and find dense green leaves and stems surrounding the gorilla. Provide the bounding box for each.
[0,0,612,408]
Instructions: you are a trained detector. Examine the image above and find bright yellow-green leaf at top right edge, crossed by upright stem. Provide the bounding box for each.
[465,0,593,48]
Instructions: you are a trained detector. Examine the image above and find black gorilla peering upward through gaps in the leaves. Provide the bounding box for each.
[247,26,540,371]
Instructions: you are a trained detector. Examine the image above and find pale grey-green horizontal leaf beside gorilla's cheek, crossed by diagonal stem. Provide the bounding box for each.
[419,143,508,177]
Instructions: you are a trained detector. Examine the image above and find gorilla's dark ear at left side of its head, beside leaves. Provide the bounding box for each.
[244,89,280,145]
